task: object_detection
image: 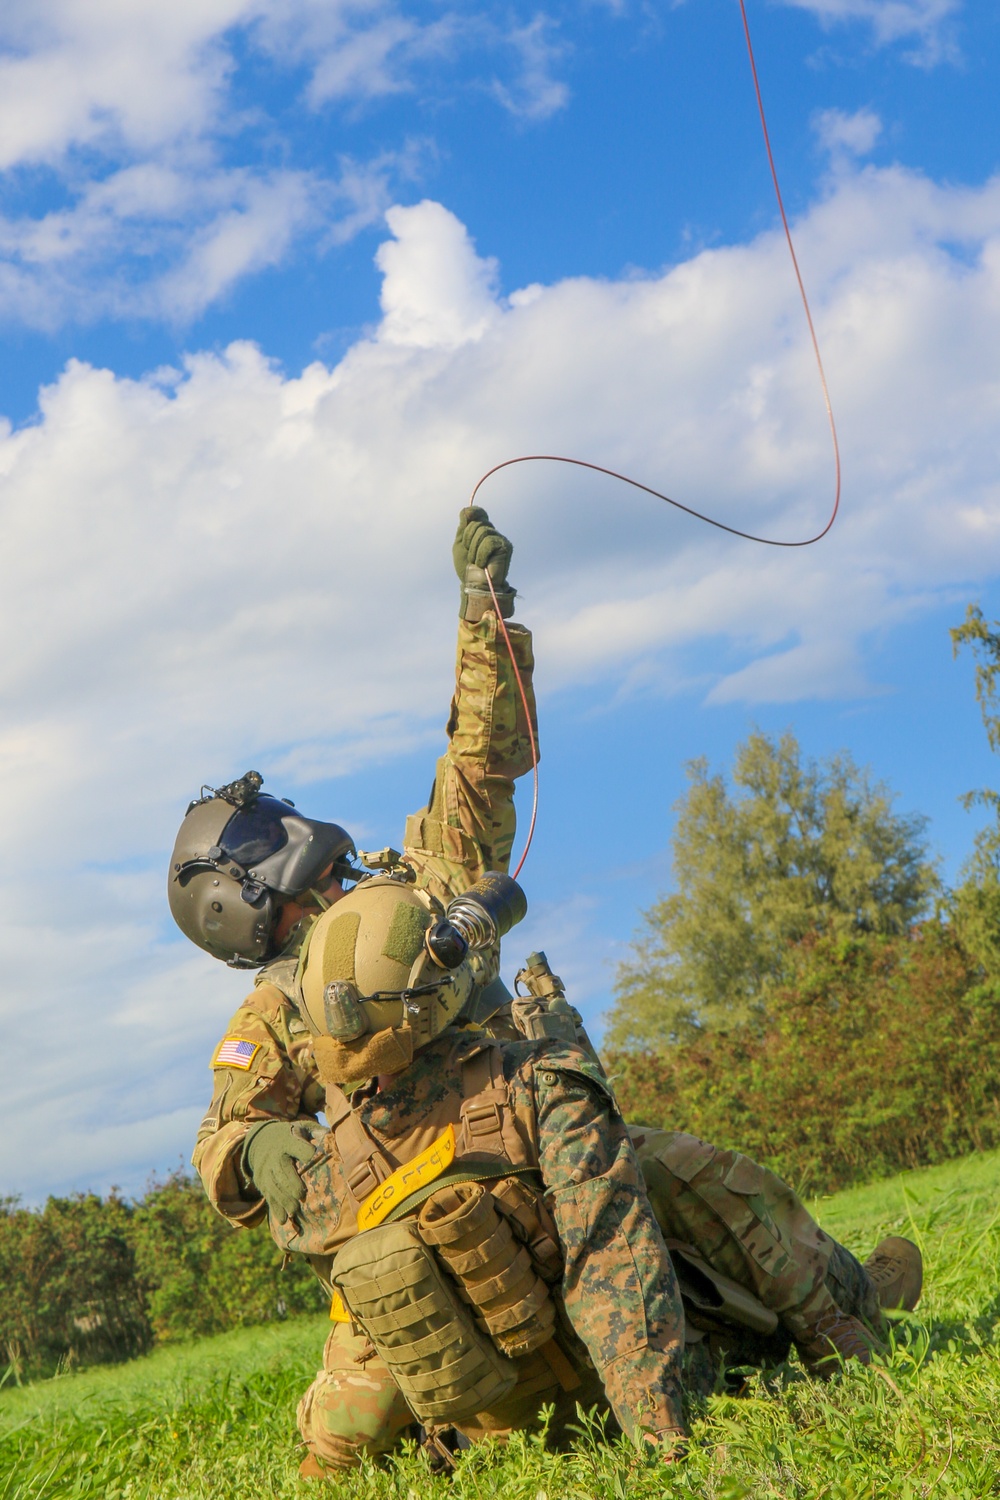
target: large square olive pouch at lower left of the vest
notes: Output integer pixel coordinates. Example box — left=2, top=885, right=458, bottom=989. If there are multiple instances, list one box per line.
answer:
left=330, top=1220, right=517, bottom=1427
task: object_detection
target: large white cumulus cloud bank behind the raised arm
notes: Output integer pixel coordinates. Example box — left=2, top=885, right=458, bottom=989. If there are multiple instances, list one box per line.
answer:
left=0, top=168, right=1000, bottom=1193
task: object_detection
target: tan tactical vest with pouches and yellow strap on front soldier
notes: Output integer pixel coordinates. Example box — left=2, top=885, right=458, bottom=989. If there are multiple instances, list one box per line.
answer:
left=281, top=1032, right=589, bottom=1425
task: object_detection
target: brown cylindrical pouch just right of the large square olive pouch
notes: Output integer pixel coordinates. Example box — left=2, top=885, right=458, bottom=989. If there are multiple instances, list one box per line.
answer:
left=417, top=1182, right=556, bottom=1358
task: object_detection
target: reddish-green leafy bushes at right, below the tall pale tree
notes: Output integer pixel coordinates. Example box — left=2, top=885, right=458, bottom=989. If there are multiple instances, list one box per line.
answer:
left=607, top=923, right=1000, bottom=1193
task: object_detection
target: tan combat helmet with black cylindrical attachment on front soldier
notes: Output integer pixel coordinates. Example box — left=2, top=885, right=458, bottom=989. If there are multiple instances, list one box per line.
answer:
left=301, top=875, right=526, bottom=1085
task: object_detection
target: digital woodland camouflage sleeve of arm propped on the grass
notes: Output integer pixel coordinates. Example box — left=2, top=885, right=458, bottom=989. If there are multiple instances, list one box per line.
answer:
left=532, top=1047, right=684, bottom=1445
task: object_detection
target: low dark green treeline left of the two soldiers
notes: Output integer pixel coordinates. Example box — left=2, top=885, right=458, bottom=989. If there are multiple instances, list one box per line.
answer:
left=0, top=1172, right=324, bottom=1385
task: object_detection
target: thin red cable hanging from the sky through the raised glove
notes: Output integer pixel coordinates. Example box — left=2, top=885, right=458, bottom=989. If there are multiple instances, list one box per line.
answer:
left=469, top=0, right=841, bottom=879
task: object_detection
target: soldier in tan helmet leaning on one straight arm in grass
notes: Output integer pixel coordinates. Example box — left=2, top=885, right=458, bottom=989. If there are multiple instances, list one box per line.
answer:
left=217, top=866, right=919, bottom=1475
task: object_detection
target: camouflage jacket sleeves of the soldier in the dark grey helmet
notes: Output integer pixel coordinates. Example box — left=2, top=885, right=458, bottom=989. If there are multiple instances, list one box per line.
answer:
left=192, top=614, right=537, bottom=1226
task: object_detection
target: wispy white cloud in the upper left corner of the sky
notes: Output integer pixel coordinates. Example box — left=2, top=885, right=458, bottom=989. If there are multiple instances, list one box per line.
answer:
left=0, top=0, right=565, bottom=329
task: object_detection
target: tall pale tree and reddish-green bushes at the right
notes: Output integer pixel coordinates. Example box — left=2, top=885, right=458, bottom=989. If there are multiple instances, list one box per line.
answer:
left=606, top=606, right=1000, bottom=1193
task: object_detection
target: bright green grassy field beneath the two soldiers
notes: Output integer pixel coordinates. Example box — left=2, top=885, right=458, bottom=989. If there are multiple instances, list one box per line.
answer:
left=0, top=1154, right=1000, bottom=1500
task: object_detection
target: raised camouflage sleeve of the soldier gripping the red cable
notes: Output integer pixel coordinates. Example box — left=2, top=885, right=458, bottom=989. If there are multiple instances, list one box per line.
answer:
left=405, top=612, right=538, bottom=902
